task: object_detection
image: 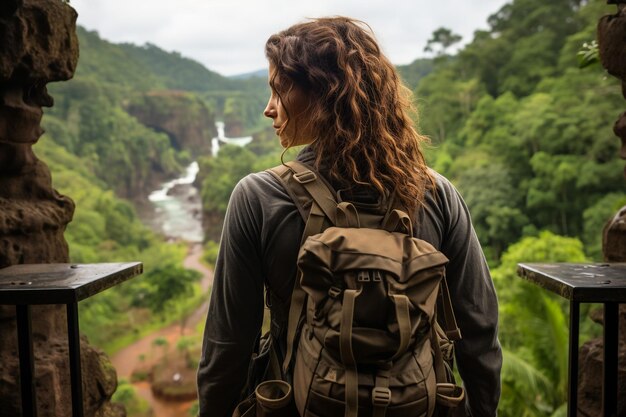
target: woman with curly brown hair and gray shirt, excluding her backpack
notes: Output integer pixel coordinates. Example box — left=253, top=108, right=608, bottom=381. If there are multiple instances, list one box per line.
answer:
left=198, top=17, right=502, bottom=417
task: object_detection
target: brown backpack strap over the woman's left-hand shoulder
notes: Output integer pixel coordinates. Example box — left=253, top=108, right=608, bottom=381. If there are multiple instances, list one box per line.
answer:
left=268, top=161, right=337, bottom=373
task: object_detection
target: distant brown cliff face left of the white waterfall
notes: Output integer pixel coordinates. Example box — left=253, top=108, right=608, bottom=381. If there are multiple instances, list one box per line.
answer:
left=127, top=91, right=217, bottom=159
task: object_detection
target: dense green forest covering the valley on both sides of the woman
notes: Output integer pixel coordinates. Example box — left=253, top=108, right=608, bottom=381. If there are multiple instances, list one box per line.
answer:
left=35, top=0, right=626, bottom=416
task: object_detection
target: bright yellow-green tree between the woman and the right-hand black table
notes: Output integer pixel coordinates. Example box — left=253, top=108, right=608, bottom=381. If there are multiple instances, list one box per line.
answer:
left=492, top=231, right=586, bottom=417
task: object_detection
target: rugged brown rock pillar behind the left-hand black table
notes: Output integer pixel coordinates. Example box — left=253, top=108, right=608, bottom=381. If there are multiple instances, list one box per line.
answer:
left=0, top=0, right=124, bottom=417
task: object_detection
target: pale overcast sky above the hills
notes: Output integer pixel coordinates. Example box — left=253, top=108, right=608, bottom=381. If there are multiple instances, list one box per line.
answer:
left=70, top=0, right=508, bottom=75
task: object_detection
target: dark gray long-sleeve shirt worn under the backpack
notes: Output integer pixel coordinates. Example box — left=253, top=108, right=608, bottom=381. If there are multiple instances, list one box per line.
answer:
left=198, top=152, right=502, bottom=417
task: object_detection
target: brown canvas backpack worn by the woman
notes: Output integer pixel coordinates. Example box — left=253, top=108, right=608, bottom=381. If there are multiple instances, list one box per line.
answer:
left=269, top=162, right=464, bottom=417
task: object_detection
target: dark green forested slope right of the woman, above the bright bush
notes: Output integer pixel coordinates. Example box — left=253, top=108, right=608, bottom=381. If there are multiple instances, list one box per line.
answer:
left=415, top=0, right=625, bottom=264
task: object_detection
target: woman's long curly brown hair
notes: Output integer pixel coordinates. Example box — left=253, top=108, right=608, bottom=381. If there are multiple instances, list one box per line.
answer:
left=265, top=17, right=434, bottom=214
